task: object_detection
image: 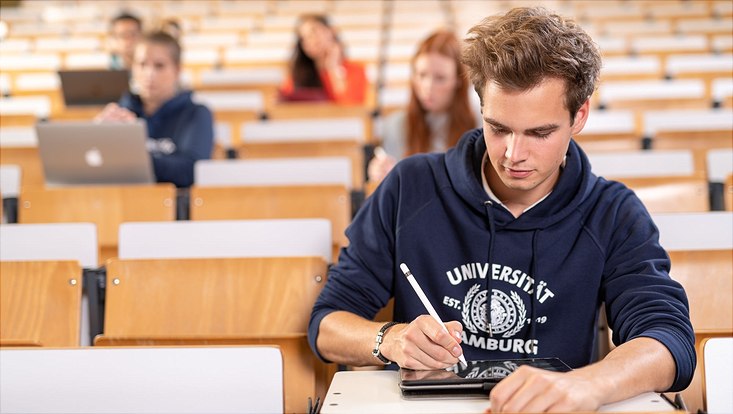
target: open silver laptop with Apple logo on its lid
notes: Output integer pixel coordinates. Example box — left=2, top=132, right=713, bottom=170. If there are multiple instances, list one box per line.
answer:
left=36, top=120, right=155, bottom=186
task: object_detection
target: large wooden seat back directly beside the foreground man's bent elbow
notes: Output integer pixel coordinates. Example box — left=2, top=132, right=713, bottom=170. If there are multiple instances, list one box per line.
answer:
left=95, top=257, right=327, bottom=412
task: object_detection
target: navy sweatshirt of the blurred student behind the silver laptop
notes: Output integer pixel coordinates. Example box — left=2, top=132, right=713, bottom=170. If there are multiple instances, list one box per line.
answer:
left=119, top=91, right=214, bottom=187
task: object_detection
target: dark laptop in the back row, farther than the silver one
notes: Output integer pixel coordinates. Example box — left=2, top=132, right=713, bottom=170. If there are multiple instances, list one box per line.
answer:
left=58, top=69, right=130, bottom=106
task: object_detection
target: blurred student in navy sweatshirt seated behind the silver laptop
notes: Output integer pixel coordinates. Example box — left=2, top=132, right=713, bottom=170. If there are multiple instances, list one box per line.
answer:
left=95, top=32, right=214, bottom=187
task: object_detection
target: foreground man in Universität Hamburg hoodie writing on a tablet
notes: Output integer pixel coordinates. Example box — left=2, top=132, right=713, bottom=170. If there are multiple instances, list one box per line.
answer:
left=308, top=7, right=696, bottom=413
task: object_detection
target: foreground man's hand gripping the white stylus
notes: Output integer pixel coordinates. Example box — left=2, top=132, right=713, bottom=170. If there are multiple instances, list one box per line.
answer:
left=380, top=315, right=463, bottom=369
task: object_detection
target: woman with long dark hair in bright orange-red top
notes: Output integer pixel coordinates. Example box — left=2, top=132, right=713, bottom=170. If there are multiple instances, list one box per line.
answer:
left=280, top=15, right=367, bottom=105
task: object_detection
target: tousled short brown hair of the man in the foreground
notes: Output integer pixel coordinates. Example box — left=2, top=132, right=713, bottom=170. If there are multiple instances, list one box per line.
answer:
left=463, top=7, right=601, bottom=122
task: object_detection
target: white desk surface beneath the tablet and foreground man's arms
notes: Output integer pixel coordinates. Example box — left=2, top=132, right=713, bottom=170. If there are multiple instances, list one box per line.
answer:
left=321, top=370, right=675, bottom=414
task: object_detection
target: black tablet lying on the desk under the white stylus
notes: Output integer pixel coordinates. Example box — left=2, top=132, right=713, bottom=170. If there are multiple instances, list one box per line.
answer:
left=400, top=358, right=571, bottom=397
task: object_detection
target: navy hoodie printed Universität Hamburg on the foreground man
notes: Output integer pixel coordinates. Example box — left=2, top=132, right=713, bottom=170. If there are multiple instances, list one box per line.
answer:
left=308, top=129, right=695, bottom=390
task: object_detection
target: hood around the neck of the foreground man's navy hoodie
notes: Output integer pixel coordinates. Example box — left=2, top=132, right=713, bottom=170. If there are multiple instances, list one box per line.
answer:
left=445, top=128, right=597, bottom=230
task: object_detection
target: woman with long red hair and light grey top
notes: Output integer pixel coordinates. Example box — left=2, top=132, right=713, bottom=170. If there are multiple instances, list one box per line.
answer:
left=368, top=31, right=480, bottom=182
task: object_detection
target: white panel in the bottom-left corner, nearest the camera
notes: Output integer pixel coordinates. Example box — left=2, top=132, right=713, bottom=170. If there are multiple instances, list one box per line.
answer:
left=0, top=346, right=284, bottom=414
